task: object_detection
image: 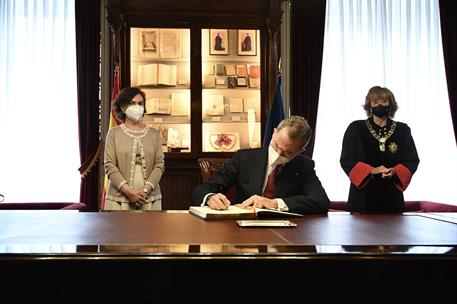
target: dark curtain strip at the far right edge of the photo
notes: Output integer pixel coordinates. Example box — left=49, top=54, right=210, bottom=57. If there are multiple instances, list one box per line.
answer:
left=440, top=0, right=457, bottom=143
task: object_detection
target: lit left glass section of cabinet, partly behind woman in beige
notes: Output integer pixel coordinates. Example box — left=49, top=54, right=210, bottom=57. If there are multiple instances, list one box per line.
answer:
left=130, top=27, right=191, bottom=152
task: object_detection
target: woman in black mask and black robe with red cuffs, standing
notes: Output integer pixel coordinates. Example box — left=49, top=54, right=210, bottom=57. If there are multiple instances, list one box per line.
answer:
left=340, top=86, right=419, bottom=213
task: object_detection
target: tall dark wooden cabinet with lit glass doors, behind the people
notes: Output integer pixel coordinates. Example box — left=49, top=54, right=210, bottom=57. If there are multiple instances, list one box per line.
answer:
left=107, top=0, right=281, bottom=209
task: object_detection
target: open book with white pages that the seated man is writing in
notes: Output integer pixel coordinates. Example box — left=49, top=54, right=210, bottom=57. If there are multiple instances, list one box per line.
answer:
left=189, top=206, right=303, bottom=220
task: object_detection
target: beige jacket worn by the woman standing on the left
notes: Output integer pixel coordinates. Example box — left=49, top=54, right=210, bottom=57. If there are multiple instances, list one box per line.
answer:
left=105, top=126, right=165, bottom=202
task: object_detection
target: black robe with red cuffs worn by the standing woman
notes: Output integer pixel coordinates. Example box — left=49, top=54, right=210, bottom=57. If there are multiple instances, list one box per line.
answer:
left=340, top=118, right=419, bottom=213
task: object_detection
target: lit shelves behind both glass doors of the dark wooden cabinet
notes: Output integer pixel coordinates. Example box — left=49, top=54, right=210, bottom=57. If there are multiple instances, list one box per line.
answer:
left=130, top=27, right=261, bottom=153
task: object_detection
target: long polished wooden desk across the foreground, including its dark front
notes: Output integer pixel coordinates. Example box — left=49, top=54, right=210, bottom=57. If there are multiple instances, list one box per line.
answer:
left=0, top=210, right=457, bottom=303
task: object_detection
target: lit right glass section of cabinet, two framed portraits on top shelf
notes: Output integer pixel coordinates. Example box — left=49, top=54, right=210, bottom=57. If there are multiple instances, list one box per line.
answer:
left=202, top=29, right=261, bottom=152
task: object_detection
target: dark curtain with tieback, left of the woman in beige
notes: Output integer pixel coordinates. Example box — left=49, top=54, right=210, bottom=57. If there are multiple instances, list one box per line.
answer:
left=75, top=0, right=100, bottom=210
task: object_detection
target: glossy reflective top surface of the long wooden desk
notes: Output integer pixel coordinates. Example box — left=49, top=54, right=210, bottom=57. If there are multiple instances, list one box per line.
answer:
left=0, top=210, right=457, bottom=257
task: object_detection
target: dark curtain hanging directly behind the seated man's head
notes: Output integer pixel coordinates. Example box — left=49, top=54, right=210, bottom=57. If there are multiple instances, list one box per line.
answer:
left=290, top=0, right=327, bottom=157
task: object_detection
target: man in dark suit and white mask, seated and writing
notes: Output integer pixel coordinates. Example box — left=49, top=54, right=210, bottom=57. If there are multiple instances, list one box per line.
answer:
left=192, top=116, right=330, bottom=214
